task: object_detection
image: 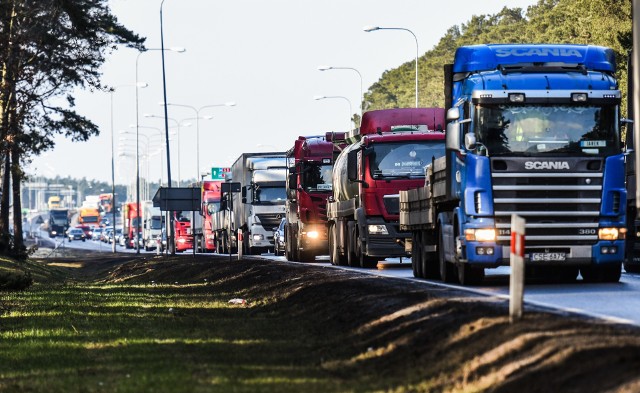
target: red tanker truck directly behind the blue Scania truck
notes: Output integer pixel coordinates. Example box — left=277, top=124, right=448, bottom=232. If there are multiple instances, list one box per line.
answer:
left=327, top=108, right=445, bottom=267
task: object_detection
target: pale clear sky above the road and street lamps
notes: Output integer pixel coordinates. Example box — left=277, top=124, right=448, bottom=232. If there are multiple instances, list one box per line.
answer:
left=26, top=0, right=537, bottom=184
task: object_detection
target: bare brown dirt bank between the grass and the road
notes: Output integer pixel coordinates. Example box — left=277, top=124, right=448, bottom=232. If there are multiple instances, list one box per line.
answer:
left=22, top=254, right=640, bottom=393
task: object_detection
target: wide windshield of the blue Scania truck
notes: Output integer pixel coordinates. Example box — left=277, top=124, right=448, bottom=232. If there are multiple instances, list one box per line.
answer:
left=475, top=105, right=620, bottom=156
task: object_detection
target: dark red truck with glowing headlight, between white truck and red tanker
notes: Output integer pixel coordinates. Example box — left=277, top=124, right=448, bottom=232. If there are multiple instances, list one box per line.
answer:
left=284, top=132, right=346, bottom=262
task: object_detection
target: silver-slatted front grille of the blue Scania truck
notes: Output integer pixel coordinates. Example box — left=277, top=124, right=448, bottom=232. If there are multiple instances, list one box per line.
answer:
left=491, top=158, right=603, bottom=247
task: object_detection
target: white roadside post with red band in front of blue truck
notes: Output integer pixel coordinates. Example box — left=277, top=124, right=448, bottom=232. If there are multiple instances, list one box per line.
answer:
left=509, top=214, right=525, bottom=323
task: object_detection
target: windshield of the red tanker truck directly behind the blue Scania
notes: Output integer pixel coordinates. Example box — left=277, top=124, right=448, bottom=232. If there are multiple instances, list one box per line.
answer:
left=365, top=141, right=445, bottom=179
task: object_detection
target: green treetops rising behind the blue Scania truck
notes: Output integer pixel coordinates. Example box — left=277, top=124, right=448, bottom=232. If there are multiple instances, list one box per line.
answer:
left=364, top=0, right=631, bottom=113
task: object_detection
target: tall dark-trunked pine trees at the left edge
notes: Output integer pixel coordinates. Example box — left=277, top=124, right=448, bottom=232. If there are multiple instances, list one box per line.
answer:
left=0, top=0, right=144, bottom=258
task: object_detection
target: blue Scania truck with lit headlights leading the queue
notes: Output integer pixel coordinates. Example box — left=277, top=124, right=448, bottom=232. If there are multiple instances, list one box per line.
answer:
left=400, top=44, right=627, bottom=285
